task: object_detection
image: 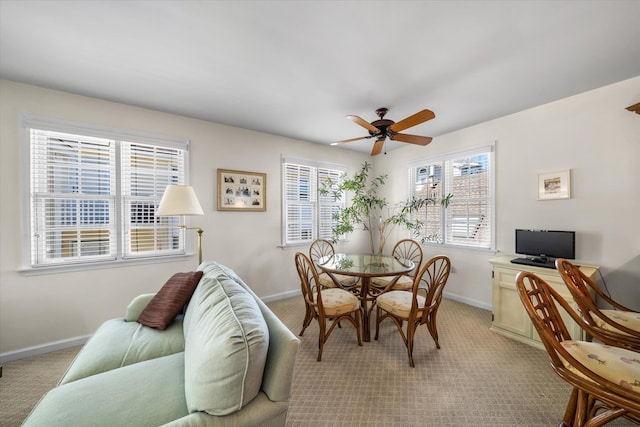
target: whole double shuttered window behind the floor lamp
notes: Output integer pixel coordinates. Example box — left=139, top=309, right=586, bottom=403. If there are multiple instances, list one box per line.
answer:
left=24, top=117, right=188, bottom=267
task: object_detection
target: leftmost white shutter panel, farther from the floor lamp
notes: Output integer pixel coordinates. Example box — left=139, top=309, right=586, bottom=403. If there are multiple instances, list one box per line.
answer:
left=30, top=129, right=117, bottom=267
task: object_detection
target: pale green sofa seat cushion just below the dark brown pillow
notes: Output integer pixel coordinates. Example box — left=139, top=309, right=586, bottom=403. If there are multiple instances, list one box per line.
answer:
left=60, top=316, right=184, bottom=384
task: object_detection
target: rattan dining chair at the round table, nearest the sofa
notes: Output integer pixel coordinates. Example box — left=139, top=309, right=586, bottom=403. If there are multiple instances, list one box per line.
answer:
left=295, top=252, right=362, bottom=362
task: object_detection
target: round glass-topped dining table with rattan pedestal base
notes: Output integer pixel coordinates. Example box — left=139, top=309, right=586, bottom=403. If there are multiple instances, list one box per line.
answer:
left=316, top=254, right=415, bottom=341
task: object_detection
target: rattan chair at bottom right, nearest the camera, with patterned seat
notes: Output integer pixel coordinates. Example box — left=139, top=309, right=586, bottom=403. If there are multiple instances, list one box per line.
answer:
left=516, top=272, right=640, bottom=426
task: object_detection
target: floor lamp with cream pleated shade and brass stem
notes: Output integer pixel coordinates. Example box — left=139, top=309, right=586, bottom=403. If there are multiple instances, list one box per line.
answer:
left=156, top=185, right=204, bottom=265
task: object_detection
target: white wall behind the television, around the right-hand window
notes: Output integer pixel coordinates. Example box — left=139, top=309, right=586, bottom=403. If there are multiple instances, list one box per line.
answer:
left=375, top=77, right=640, bottom=309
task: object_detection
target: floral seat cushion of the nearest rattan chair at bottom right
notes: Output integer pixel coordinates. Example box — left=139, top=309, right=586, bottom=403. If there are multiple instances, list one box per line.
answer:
left=562, top=340, right=640, bottom=399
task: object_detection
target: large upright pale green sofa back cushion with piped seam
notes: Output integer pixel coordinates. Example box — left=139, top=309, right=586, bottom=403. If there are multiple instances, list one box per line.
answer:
left=184, top=268, right=269, bottom=415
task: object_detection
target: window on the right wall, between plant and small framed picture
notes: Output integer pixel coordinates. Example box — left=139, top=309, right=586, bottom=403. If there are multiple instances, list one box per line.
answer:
left=409, top=145, right=494, bottom=249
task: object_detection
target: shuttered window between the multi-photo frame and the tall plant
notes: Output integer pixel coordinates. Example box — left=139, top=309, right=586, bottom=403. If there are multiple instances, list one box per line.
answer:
left=282, top=159, right=344, bottom=246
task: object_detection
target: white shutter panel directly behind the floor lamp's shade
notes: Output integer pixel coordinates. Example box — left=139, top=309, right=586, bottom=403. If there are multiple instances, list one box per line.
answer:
left=121, top=142, right=185, bottom=258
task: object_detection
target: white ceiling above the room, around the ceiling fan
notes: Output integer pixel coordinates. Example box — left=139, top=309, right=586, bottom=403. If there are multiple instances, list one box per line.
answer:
left=0, top=0, right=640, bottom=152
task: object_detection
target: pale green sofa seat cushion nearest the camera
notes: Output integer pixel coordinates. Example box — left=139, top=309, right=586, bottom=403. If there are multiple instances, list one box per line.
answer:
left=23, top=352, right=188, bottom=427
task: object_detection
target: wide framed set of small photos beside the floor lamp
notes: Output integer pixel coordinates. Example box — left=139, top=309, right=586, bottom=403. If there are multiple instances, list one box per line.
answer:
left=218, top=169, right=267, bottom=212
